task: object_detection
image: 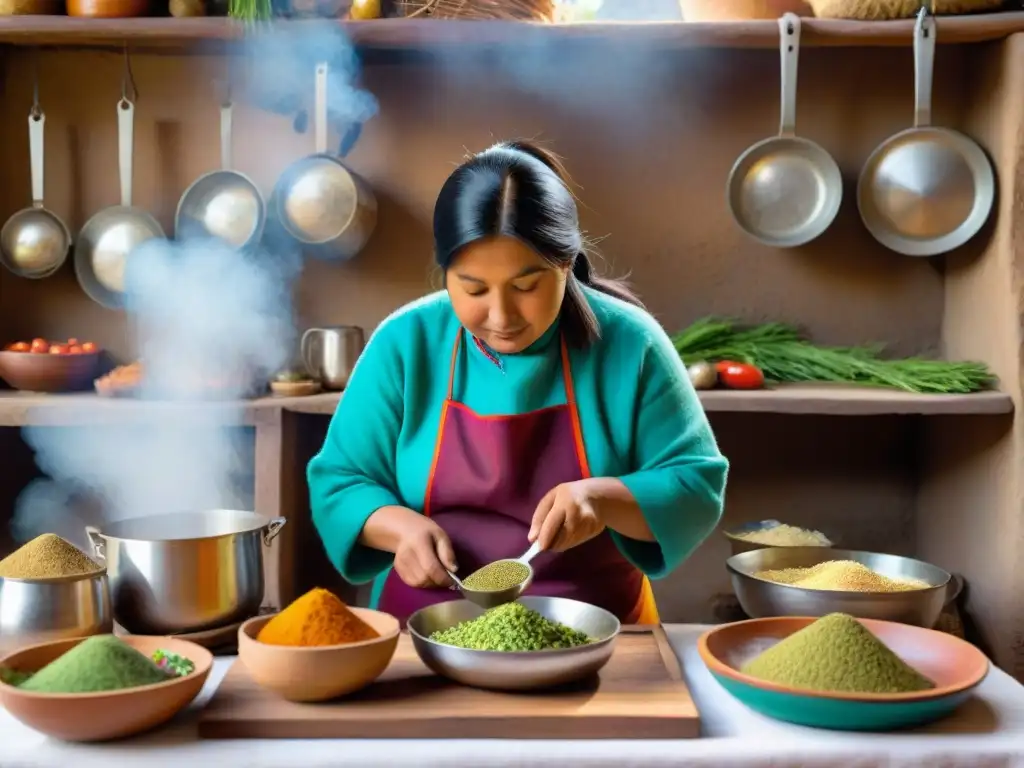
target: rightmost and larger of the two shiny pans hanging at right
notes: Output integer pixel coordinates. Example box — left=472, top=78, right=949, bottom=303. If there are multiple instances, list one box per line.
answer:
left=857, top=8, right=995, bottom=256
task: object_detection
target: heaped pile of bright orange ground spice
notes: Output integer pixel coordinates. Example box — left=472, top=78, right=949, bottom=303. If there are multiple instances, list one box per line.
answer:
left=256, top=588, right=380, bottom=647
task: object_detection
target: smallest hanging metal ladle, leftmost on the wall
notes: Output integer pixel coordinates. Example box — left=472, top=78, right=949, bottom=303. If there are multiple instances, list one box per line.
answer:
left=0, top=60, right=71, bottom=280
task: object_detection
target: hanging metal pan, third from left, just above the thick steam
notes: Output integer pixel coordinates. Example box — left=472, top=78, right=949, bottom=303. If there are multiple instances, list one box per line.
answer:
left=174, top=96, right=266, bottom=248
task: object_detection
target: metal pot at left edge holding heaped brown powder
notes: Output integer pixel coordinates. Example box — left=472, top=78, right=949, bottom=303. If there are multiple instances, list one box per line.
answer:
left=0, top=570, right=114, bottom=651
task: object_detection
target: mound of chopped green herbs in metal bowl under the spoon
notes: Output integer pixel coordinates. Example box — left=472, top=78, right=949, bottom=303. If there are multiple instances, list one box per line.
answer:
left=430, top=603, right=590, bottom=651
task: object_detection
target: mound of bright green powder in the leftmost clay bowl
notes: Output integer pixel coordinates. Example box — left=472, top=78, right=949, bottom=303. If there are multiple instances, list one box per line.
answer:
left=18, top=635, right=170, bottom=693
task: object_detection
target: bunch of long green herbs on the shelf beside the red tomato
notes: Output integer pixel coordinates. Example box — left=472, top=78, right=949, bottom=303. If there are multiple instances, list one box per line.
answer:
left=672, top=317, right=995, bottom=394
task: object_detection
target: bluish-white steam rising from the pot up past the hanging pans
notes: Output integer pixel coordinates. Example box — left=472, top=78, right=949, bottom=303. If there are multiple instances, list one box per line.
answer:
left=11, top=25, right=377, bottom=551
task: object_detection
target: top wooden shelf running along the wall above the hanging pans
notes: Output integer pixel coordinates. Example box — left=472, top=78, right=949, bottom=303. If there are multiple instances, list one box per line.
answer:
left=0, top=11, right=1024, bottom=50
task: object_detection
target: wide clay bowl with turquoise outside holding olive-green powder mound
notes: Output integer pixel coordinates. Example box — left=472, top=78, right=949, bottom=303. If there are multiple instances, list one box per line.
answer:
left=697, top=616, right=989, bottom=731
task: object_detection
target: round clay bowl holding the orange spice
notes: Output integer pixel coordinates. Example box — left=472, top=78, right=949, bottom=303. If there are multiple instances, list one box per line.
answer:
left=239, top=608, right=399, bottom=701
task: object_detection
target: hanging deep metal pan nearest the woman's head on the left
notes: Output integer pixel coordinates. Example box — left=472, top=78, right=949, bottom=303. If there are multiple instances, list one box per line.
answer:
left=270, top=62, right=377, bottom=260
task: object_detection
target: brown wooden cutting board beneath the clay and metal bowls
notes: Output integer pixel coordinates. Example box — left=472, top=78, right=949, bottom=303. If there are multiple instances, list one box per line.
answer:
left=199, top=627, right=700, bottom=739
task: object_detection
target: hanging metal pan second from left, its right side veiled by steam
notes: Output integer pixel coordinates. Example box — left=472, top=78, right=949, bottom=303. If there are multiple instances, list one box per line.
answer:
left=75, top=59, right=166, bottom=309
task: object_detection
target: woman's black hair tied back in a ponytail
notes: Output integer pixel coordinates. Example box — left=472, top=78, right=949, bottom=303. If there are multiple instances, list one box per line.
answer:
left=434, top=141, right=643, bottom=347
